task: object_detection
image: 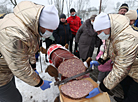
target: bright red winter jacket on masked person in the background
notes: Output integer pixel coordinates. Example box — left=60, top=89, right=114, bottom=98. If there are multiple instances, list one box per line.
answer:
left=67, top=16, right=81, bottom=35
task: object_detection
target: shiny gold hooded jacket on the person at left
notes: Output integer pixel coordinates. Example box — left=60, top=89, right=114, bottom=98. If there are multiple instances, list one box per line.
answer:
left=0, top=1, right=44, bottom=86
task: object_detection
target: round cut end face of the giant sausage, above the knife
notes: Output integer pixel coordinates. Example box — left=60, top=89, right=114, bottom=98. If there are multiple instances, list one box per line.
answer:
left=58, top=59, right=86, bottom=77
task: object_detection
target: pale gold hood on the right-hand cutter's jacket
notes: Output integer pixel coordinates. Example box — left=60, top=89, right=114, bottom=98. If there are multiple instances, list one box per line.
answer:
left=109, top=14, right=129, bottom=39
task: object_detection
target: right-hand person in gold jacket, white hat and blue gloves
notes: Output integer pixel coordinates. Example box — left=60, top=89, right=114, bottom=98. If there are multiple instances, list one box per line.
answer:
left=86, top=13, right=138, bottom=102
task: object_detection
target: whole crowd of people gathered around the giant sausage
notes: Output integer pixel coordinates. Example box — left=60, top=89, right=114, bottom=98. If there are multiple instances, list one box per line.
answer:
left=0, top=1, right=138, bottom=102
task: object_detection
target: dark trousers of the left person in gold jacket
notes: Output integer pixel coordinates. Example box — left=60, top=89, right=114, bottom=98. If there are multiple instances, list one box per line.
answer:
left=0, top=77, right=22, bottom=102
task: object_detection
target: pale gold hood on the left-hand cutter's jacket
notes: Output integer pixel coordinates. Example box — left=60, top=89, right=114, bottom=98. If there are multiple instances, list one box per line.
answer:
left=14, top=1, right=44, bottom=34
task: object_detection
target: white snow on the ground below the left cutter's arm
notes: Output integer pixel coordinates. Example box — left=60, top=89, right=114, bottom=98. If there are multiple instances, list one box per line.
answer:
left=15, top=41, right=59, bottom=102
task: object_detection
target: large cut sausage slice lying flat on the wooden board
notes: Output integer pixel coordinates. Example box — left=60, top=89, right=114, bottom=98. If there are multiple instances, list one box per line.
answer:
left=60, top=80, right=94, bottom=99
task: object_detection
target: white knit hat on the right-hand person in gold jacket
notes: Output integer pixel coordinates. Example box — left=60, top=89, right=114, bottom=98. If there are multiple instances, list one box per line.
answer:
left=93, top=12, right=111, bottom=31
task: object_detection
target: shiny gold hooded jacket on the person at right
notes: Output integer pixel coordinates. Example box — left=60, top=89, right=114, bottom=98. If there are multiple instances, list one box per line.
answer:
left=98, top=14, right=138, bottom=89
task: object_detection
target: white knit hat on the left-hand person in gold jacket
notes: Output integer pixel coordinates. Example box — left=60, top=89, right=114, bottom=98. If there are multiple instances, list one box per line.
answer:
left=39, top=5, right=59, bottom=30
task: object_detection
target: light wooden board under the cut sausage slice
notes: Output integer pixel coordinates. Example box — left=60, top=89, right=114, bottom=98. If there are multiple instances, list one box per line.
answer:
left=59, top=78, right=111, bottom=102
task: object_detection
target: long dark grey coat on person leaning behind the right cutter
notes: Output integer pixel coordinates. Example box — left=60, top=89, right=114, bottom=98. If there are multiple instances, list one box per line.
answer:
left=75, top=19, right=100, bottom=59
